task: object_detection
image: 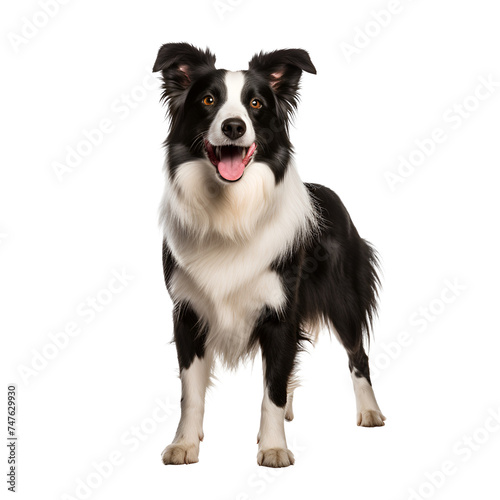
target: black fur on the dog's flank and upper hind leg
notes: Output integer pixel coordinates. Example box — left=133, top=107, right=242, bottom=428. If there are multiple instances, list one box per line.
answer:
left=298, top=184, right=380, bottom=382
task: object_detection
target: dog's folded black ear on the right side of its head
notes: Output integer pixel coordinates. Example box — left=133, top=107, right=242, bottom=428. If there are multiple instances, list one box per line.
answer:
left=248, top=49, right=316, bottom=117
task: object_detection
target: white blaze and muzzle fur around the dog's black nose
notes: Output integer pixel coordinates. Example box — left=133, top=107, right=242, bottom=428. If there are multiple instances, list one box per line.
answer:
left=207, top=71, right=255, bottom=147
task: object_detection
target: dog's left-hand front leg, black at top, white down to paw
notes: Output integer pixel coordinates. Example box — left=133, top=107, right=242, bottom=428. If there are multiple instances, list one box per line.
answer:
left=162, top=306, right=212, bottom=465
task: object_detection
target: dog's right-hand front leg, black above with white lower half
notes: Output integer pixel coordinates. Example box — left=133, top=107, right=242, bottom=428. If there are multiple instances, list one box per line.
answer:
left=256, top=312, right=297, bottom=467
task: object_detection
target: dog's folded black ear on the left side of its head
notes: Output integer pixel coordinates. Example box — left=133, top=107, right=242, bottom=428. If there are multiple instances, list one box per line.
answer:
left=153, top=43, right=215, bottom=108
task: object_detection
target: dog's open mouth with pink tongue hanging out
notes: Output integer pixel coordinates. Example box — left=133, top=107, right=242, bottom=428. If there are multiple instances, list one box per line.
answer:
left=205, top=141, right=257, bottom=182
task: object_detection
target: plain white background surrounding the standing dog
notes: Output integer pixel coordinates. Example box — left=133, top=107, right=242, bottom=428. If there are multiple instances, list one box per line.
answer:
left=0, top=0, right=500, bottom=500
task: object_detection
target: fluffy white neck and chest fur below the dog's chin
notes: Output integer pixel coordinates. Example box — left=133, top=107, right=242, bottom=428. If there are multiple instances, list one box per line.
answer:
left=161, top=161, right=314, bottom=365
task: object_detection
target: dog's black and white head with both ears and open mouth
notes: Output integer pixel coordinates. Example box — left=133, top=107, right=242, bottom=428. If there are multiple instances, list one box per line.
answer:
left=153, top=43, right=316, bottom=182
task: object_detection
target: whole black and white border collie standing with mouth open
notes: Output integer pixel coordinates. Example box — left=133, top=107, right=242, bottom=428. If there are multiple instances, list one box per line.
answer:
left=153, top=43, right=385, bottom=467
